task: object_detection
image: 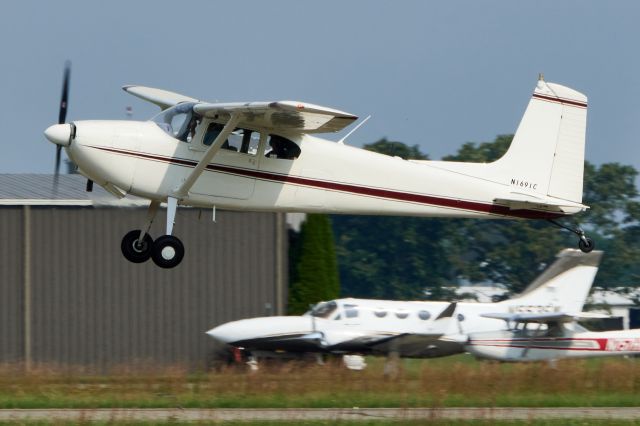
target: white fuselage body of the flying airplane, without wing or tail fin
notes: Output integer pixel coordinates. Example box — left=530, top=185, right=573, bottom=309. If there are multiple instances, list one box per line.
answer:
left=66, top=120, right=579, bottom=218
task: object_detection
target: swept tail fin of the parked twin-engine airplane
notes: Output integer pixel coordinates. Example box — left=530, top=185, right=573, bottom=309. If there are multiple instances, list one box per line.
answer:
left=500, top=249, right=602, bottom=312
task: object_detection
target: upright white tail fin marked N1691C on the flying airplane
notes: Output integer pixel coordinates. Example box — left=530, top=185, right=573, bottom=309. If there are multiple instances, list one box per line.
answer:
left=487, top=79, right=587, bottom=204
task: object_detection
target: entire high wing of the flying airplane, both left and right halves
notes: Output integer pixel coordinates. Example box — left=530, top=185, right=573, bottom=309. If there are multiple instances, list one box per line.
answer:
left=123, top=86, right=358, bottom=133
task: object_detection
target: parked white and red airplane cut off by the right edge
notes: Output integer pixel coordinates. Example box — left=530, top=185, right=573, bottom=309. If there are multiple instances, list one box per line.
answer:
left=465, top=312, right=640, bottom=362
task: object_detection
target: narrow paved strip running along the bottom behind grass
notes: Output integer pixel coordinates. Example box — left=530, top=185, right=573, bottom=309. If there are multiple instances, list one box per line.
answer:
left=0, top=407, right=640, bottom=422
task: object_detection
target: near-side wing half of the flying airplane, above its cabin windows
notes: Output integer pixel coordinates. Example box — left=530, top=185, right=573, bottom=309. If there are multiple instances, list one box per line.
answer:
left=193, top=101, right=358, bottom=133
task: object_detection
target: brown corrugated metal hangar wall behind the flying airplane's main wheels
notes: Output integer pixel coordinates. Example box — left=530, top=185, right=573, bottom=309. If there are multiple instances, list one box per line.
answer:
left=0, top=207, right=286, bottom=368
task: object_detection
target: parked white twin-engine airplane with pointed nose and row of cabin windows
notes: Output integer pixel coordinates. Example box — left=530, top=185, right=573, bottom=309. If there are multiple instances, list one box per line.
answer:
left=207, top=249, right=602, bottom=366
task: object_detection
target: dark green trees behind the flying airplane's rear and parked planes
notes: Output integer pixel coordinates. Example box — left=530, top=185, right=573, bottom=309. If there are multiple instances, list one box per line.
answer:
left=290, top=135, right=640, bottom=312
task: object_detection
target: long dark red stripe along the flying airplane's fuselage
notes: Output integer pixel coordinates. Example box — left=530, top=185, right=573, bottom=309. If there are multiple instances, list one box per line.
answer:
left=88, top=145, right=564, bottom=219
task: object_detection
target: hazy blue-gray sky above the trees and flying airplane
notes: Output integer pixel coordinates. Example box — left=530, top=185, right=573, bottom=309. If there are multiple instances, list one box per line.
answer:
left=0, top=0, right=640, bottom=173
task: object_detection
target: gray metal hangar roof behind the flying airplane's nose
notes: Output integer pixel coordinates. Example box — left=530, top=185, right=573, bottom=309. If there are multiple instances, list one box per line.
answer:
left=0, top=173, right=146, bottom=206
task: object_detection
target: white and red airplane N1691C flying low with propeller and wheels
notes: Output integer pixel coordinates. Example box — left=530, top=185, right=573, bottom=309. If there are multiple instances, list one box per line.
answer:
left=45, top=66, right=593, bottom=268
